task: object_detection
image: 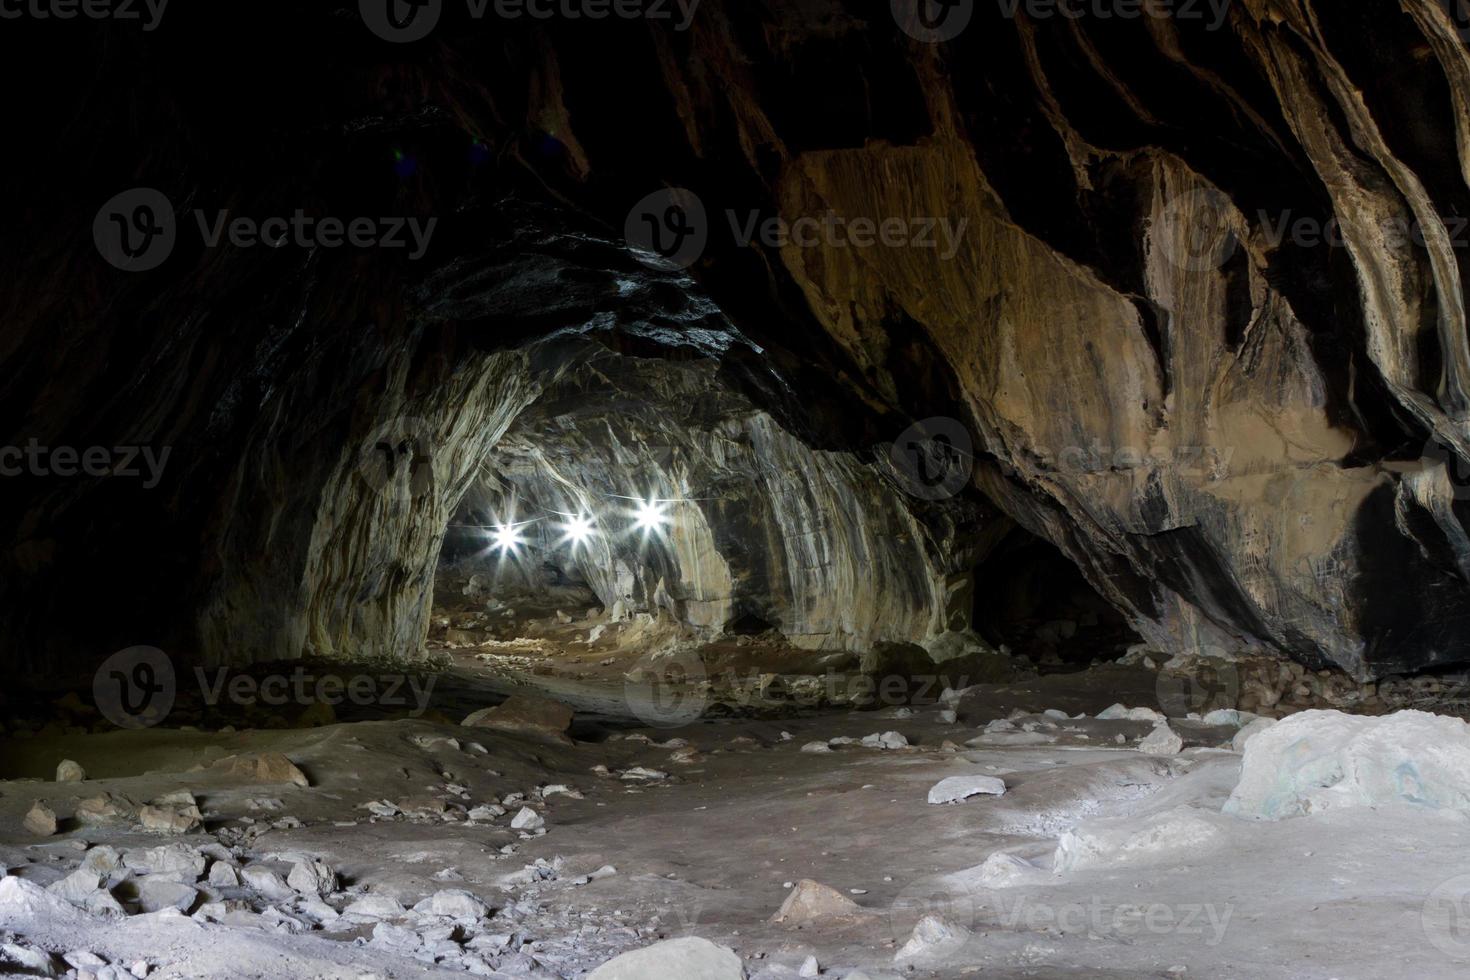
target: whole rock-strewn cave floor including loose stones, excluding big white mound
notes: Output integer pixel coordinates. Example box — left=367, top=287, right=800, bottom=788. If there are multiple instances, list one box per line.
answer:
left=0, top=605, right=1470, bottom=980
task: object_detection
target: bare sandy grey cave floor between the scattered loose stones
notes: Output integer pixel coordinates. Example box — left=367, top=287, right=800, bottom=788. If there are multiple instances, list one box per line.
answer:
left=0, top=654, right=1470, bottom=979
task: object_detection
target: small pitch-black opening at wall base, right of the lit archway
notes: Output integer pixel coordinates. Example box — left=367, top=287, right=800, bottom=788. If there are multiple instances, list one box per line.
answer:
left=972, top=526, right=1142, bottom=670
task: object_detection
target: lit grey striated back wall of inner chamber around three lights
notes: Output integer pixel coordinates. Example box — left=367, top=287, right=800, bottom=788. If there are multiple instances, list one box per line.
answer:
left=466, top=340, right=979, bottom=651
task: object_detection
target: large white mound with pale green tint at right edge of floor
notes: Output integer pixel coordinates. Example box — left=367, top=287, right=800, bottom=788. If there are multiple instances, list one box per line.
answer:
left=1225, top=711, right=1470, bottom=820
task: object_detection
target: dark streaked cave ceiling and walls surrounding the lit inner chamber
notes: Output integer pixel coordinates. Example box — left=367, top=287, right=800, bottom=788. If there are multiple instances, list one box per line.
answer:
left=0, top=0, right=1470, bottom=677
